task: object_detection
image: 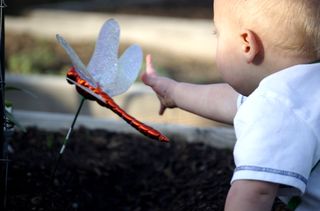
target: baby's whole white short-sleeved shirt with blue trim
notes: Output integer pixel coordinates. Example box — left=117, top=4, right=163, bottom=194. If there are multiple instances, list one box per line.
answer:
left=231, top=63, right=320, bottom=211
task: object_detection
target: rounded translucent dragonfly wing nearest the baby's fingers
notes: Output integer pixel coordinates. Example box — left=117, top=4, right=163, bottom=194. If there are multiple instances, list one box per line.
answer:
left=101, top=45, right=143, bottom=96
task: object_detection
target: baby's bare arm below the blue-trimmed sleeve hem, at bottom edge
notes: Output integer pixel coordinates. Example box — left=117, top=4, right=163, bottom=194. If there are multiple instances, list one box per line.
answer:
left=225, top=180, right=278, bottom=211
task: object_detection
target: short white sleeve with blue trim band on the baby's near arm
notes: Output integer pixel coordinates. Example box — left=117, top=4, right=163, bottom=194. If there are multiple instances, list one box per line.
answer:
left=231, top=92, right=316, bottom=196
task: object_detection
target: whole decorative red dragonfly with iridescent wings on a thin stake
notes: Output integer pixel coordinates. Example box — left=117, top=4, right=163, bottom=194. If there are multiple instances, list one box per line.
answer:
left=56, top=19, right=169, bottom=144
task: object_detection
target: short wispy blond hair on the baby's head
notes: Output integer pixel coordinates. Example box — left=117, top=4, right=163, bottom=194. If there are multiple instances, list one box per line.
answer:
left=232, top=0, right=320, bottom=59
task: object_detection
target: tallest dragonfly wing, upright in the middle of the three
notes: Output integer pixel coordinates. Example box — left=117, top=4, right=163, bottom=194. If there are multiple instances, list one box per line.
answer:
left=88, top=19, right=120, bottom=85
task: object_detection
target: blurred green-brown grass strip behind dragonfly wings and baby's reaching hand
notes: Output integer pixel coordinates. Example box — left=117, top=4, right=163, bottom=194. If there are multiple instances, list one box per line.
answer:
left=5, top=33, right=219, bottom=83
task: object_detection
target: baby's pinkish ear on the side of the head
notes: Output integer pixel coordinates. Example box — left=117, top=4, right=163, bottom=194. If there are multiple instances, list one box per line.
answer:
left=241, top=29, right=262, bottom=64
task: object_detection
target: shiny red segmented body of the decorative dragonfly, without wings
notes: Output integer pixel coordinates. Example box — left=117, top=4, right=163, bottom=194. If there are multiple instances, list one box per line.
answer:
left=67, top=67, right=169, bottom=142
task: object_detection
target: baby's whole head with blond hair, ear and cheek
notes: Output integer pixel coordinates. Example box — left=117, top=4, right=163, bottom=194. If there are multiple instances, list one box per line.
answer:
left=214, top=0, right=320, bottom=95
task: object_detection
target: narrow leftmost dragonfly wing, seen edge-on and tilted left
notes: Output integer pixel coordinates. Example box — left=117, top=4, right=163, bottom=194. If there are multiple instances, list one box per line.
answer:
left=56, top=34, right=97, bottom=87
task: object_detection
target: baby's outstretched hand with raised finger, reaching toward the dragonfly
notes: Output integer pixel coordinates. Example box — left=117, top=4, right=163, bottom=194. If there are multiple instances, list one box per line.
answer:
left=141, top=54, right=177, bottom=115
